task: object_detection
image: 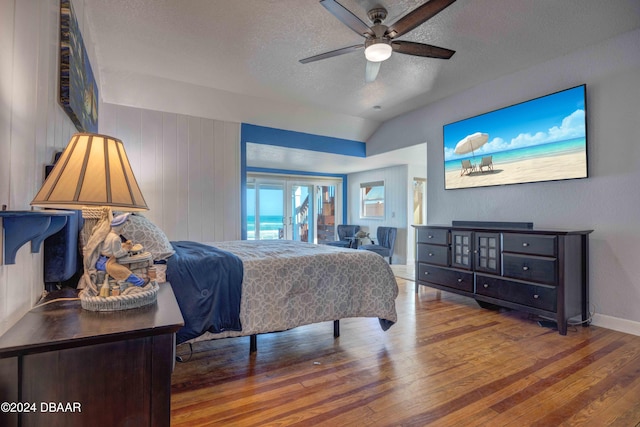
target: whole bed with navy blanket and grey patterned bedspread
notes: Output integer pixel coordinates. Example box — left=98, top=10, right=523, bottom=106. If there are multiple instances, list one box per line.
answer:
left=166, top=240, right=398, bottom=351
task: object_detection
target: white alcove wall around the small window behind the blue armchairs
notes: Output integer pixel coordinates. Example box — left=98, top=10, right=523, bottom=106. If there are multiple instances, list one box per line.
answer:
left=347, top=165, right=413, bottom=264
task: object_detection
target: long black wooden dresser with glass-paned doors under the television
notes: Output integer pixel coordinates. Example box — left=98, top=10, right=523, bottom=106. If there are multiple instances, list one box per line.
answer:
left=414, top=222, right=592, bottom=335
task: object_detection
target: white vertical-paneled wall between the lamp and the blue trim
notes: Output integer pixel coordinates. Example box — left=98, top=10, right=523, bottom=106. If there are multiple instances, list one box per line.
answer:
left=99, top=103, right=241, bottom=242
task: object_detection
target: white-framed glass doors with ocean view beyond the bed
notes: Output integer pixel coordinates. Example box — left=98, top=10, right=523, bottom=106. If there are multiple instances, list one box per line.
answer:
left=247, top=175, right=341, bottom=243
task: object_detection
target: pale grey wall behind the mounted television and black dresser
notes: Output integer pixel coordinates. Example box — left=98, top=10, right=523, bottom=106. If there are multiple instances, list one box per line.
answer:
left=367, top=30, right=640, bottom=334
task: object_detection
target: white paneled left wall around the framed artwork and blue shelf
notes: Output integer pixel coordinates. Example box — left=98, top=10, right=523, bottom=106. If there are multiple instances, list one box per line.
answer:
left=0, top=0, right=99, bottom=334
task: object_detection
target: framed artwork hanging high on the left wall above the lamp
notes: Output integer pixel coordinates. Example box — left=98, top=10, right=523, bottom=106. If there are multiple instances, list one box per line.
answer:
left=60, top=0, right=99, bottom=133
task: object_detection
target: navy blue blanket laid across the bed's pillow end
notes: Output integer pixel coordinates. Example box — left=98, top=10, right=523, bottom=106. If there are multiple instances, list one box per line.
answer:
left=167, top=241, right=243, bottom=344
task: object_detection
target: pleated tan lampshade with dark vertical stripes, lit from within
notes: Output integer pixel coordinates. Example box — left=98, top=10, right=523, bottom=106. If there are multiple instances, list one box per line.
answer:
left=31, top=133, right=149, bottom=211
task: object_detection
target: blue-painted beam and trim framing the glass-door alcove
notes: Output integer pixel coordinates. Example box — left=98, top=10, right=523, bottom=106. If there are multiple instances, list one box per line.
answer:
left=240, top=123, right=366, bottom=239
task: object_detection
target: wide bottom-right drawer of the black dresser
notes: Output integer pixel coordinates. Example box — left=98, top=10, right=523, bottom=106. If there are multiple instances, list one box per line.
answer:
left=476, top=274, right=558, bottom=312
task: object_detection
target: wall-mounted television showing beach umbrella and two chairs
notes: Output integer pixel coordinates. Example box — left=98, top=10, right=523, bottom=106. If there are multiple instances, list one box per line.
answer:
left=443, top=85, right=587, bottom=190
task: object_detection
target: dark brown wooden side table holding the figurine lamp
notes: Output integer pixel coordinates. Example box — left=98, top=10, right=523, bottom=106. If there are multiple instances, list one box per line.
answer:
left=0, top=284, right=184, bottom=427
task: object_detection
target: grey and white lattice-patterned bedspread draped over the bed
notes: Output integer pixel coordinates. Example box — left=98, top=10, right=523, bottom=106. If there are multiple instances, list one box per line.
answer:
left=182, top=240, right=398, bottom=342
